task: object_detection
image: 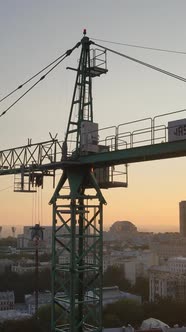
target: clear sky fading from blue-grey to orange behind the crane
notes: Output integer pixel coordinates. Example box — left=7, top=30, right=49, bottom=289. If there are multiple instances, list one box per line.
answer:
left=0, top=0, right=186, bottom=230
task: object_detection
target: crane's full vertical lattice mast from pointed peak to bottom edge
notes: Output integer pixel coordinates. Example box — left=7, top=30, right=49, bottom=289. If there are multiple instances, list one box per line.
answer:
left=51, top=30, right=105, bottom=332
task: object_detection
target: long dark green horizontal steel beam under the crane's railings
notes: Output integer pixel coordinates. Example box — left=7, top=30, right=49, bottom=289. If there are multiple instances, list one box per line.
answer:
left=0, top=140, right=186, bottom=176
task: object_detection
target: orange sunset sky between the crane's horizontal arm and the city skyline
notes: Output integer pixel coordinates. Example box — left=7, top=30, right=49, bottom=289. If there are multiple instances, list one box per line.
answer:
left=0, top=158, right=186, bottom=232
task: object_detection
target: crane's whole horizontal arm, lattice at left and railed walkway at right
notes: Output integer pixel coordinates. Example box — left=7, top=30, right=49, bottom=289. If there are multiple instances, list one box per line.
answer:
left=0, top=109, right=186, bottom=175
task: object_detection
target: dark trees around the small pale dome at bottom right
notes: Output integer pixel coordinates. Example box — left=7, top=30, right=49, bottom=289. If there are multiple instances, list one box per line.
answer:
left=103, top=298, right=186, bottom=329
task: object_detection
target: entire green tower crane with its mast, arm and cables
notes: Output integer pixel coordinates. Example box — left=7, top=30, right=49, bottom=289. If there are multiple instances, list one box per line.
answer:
left=0, top=30, right=186, bottom=332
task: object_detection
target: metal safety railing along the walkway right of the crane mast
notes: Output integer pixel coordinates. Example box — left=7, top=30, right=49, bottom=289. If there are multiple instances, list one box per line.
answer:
left=86, top=109, right=186, bottom=152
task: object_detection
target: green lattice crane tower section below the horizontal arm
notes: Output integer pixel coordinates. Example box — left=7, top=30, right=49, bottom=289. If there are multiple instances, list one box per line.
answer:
left=52, top=167, right=105, bottom=332
